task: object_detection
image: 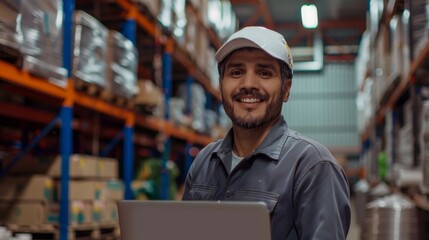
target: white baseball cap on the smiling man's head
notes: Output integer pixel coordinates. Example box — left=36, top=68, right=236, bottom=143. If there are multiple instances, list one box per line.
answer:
left=216, top=26, right=293, bottom=71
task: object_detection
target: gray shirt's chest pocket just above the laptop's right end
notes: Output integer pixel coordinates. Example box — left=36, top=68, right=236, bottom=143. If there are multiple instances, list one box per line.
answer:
left=233, top=190, right=279, bottom=214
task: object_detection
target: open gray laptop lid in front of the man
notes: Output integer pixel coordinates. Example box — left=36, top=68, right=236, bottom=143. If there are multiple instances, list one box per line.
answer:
left=118, top=200, right=271, bottom=240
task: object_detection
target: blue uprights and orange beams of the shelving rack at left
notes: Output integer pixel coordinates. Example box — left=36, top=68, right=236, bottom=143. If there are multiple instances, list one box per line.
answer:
left=0, top=0, right=226, bottom=240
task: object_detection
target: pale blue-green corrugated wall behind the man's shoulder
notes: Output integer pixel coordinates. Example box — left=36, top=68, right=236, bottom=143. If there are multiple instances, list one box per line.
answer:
left=282, top=62, right=360, bottom=152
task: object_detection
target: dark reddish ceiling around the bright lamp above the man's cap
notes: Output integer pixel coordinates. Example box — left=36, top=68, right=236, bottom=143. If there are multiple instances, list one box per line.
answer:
left=231, top=0, right=369, bottom=57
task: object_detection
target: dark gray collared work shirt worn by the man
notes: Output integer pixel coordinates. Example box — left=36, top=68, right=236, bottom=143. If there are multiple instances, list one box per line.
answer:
left=183, top=117, right=350, bottom=240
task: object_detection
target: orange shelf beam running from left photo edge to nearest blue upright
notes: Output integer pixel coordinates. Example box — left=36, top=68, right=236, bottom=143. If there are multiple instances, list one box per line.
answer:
left=0, top=60, right=66, bottom=99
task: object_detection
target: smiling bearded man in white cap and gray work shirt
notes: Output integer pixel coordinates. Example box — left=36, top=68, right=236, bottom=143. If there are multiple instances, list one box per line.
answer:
left=183, top=27, right=350, bottom=240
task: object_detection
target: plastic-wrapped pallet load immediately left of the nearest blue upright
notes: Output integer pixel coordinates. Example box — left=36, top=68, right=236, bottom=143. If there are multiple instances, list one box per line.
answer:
left=19, top=0, right=67, bottom=86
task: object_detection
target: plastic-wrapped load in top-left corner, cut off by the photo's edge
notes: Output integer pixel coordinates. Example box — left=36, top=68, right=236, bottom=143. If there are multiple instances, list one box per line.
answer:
left=0, top=0, right=22, bottom=49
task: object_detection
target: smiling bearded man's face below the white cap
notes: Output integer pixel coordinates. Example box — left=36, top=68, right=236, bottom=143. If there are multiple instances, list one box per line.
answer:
left=220, top=49, right=290, bottom=129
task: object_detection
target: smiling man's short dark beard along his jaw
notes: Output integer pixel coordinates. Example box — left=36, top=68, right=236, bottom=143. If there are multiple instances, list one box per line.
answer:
left=223, top=90, right=283, bottom=129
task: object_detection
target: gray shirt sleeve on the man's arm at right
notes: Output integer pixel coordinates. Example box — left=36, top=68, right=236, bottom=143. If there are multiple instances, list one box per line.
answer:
left=294, top=161, right=351, bottom=240
